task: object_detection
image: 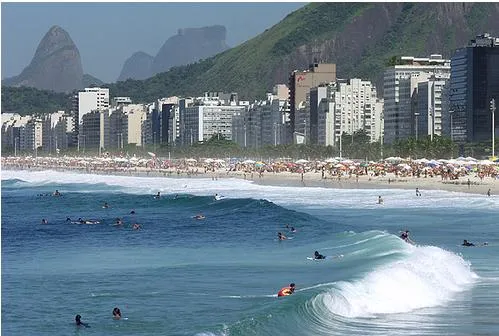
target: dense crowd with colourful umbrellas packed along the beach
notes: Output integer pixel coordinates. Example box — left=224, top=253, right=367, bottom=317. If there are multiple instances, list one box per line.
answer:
left=2, top=156, right=499, bottom=183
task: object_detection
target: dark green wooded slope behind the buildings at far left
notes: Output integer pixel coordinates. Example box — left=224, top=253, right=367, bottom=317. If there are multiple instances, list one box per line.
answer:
left=2, top=86, right=71, bottom=116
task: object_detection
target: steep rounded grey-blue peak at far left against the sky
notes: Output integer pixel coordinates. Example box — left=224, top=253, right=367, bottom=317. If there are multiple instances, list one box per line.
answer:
left=2, top=26, right=83, bottom=92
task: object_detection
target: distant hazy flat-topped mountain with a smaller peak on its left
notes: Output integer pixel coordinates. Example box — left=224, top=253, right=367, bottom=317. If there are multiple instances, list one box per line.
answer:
left=118, top=25, right=228, bottom=81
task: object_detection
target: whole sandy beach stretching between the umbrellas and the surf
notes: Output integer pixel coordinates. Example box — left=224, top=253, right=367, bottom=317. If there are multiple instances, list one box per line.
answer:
left=2, top=158, right=499, bottom=195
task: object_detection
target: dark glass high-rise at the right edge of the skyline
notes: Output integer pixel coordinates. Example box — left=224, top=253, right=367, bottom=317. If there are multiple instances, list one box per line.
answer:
left=449, top=34, right=499, bottom=143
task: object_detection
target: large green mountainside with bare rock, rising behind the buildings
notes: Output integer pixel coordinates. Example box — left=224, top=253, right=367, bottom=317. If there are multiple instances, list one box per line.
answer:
left=110, top=2, right=499, bottom=102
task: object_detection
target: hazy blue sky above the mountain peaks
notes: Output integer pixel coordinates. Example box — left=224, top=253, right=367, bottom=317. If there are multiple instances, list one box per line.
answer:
left=1, top=2, right=305, bottom=83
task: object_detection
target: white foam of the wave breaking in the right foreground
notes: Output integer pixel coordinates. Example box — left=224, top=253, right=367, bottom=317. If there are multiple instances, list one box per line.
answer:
left=312, top=246, right=477, bottom=318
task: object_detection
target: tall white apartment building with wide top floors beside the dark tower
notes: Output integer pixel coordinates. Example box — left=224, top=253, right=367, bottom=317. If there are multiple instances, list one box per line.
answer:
left=384, top=54, right=450, bottom=143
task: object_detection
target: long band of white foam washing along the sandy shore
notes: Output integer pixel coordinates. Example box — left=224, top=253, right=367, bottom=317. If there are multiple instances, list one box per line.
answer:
left=2, top=170, right=499, bottom=209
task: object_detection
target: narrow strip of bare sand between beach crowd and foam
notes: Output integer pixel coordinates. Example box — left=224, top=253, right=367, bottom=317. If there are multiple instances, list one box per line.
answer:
left=2, top=165, right=499, bottom=196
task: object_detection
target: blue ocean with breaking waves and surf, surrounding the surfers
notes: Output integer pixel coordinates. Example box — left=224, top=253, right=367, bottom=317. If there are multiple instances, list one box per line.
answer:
left=1, top=170, right=499, bottom=336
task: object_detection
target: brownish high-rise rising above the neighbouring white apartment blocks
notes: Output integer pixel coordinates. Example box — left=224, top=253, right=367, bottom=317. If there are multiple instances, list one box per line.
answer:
left=289, top=63, right=336, bottom=137
